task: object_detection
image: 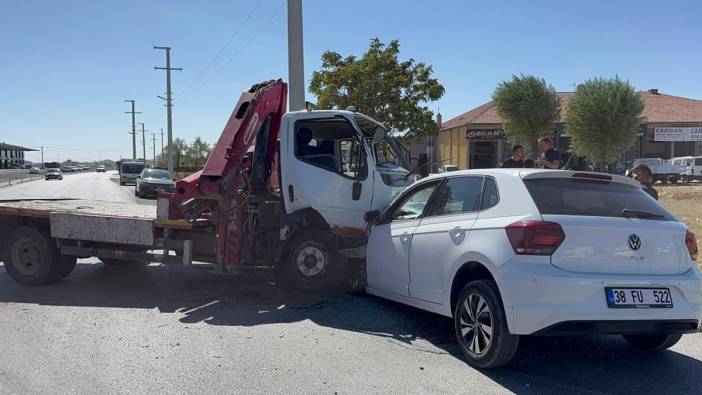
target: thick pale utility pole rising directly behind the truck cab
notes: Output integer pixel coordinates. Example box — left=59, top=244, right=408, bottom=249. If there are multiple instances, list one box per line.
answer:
left=288, top=0, right=305, bottom=111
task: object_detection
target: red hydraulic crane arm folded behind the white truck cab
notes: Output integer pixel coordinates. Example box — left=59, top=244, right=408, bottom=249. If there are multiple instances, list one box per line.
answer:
left=172, top=80, right=287, bottom=202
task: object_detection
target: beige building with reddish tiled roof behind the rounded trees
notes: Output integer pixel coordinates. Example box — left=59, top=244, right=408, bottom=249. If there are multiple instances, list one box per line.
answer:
left=434, top=89, right=702, bottom=169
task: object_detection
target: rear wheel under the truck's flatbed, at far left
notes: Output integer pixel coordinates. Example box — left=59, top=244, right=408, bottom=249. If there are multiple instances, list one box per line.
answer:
left=3, top=226, right=76, bottom=285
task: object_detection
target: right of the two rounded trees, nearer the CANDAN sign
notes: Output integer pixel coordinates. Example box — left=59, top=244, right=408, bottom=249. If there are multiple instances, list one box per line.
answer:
left=565, top=76, right=644, bottom=169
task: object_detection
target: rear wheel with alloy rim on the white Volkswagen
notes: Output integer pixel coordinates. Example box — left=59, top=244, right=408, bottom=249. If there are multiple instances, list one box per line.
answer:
left=453, top=280, right=519, bottom=368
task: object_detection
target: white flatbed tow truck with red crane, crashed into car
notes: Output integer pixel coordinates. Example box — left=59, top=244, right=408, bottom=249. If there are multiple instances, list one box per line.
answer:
left=0, top=80, right=413, bottom=291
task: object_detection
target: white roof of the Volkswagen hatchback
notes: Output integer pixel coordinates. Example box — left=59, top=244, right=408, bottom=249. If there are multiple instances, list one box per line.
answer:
left=421, top=168, right=641, bottom=187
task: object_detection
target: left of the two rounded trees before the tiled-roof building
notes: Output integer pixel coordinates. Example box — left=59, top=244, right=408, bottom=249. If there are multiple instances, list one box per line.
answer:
left=492, top=74, right=561, bottom=154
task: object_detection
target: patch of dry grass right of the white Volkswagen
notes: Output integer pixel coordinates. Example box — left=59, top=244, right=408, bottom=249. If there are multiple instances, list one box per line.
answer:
left=655, top=183, right=702, bottom=268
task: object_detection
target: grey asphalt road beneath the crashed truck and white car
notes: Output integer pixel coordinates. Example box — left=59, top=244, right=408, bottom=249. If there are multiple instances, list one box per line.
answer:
left=0, top=174, right=702, bottom=394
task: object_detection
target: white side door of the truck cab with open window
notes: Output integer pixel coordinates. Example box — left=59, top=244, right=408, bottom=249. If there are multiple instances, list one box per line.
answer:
left=281, top=113, right=373, bottom=229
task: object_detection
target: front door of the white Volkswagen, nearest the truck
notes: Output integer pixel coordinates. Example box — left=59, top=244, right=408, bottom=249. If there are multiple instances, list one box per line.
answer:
left=366, top=181, right=440, bottom=296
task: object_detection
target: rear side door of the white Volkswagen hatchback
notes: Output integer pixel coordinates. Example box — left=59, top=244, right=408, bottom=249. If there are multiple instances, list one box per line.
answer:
left=409, top=176, right=483, bottom=304
